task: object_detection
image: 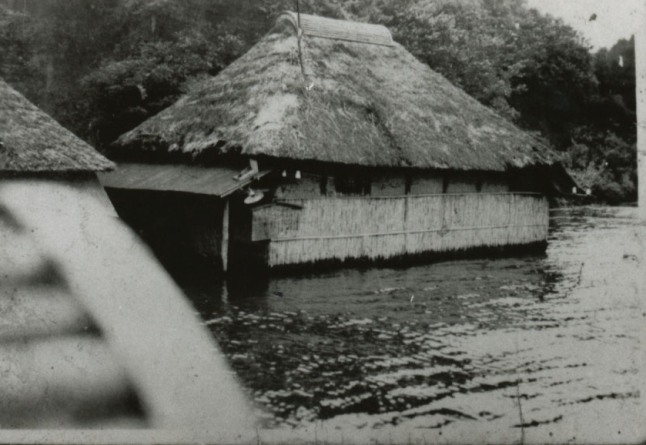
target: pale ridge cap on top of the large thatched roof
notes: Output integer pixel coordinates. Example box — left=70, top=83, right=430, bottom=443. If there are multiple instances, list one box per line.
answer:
left=279, top=11, right=393, bottom=46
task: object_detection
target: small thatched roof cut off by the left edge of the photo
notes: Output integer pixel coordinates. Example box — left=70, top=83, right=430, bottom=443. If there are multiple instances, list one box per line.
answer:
left=0, top=79, right=114, bottom=172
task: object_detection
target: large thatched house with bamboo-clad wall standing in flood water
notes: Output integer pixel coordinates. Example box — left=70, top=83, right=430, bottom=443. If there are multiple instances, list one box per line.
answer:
left=104, top=12, right=576, bottom=266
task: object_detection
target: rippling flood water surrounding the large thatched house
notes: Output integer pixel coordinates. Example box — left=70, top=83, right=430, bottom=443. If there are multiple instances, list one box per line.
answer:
left=173, top=207, right=646, bottom=443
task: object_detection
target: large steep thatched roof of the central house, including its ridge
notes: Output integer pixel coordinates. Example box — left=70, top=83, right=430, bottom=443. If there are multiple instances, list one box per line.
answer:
left=113, top=13, right=554, bottom=171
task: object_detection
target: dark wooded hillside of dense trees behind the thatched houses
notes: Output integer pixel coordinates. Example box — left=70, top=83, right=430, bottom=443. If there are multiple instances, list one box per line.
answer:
left=0, top=0, right=637, bottom=204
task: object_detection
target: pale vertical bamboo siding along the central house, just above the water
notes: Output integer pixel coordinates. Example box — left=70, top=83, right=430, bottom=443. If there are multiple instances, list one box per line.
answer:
left=253, top=193, right=548, bottom=266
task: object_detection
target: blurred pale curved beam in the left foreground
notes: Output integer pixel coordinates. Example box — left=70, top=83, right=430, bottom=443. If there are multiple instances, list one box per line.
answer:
left=0, top=179, right=251, bottom=432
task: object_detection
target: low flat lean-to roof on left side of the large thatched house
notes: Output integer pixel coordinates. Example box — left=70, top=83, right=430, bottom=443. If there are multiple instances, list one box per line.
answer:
left=99, top=163, right=268, bottom=197
